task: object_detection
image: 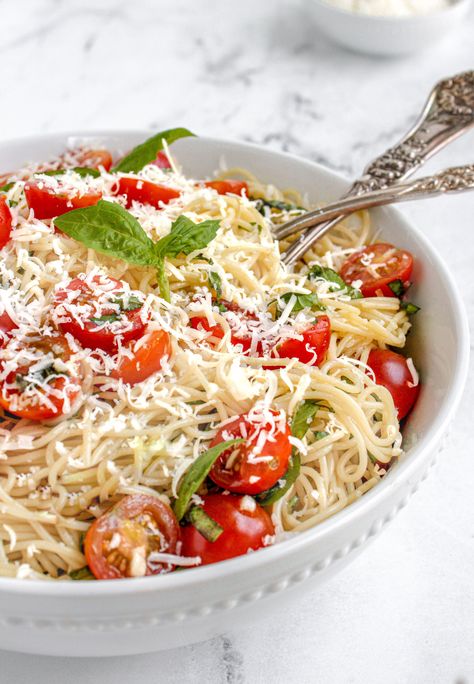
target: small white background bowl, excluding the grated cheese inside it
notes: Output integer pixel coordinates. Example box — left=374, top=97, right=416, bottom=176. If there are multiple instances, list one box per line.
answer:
left=312, top=0, right=472, bottom=56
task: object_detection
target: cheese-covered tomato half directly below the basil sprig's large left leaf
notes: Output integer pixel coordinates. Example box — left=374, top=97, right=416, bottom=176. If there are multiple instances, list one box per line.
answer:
left=53, top=275, right=146, bottom=351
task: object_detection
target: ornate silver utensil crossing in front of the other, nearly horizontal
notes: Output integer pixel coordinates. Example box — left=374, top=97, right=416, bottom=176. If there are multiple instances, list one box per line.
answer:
left=274, top=164, right=474, bottom=240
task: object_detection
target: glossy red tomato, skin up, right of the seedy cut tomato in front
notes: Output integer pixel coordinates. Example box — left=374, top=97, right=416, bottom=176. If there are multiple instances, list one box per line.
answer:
left=182, top=494, right=275, bottom=565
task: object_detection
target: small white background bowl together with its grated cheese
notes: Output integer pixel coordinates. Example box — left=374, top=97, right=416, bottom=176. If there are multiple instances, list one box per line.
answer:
left=311, top=0, right=472, bottom=56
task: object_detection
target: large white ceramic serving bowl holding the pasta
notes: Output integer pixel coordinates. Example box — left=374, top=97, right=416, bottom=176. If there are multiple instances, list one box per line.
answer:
left=0, top=132, right=469, bottom=656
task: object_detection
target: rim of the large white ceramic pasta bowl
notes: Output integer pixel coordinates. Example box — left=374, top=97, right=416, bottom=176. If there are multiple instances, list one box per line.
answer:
left=0, top=130, right=469, bottom=597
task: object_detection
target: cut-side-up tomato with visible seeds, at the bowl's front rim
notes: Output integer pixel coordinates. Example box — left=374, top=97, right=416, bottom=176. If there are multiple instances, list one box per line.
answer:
left=84, top=494, right=180, bottom=579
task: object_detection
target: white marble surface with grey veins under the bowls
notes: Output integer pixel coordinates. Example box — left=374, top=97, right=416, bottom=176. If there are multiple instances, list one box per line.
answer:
left=0, top=0, right=474, bottom=684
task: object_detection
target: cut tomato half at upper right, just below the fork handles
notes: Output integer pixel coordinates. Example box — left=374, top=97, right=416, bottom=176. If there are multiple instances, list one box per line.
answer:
left=340, top=242, right=413, bottom=297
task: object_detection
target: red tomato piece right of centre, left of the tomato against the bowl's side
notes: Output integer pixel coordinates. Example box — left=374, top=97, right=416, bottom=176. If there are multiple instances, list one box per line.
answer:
left=267, top=316, right=331, bottom=369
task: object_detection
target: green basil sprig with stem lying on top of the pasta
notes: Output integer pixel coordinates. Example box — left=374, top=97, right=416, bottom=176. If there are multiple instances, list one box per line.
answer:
left=54, top=200, right=219, bottom=301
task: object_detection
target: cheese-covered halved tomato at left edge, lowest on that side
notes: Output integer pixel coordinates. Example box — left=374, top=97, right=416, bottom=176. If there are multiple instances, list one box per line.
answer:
left=0, top=336, right=82, bottom=420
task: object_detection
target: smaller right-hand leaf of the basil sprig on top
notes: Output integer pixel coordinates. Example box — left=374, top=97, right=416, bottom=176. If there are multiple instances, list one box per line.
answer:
left=155, top=216, right=220, bottom=258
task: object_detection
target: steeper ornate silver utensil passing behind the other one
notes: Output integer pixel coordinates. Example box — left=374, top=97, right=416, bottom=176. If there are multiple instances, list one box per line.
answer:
left=282, top=71, right=474, bottom=264
